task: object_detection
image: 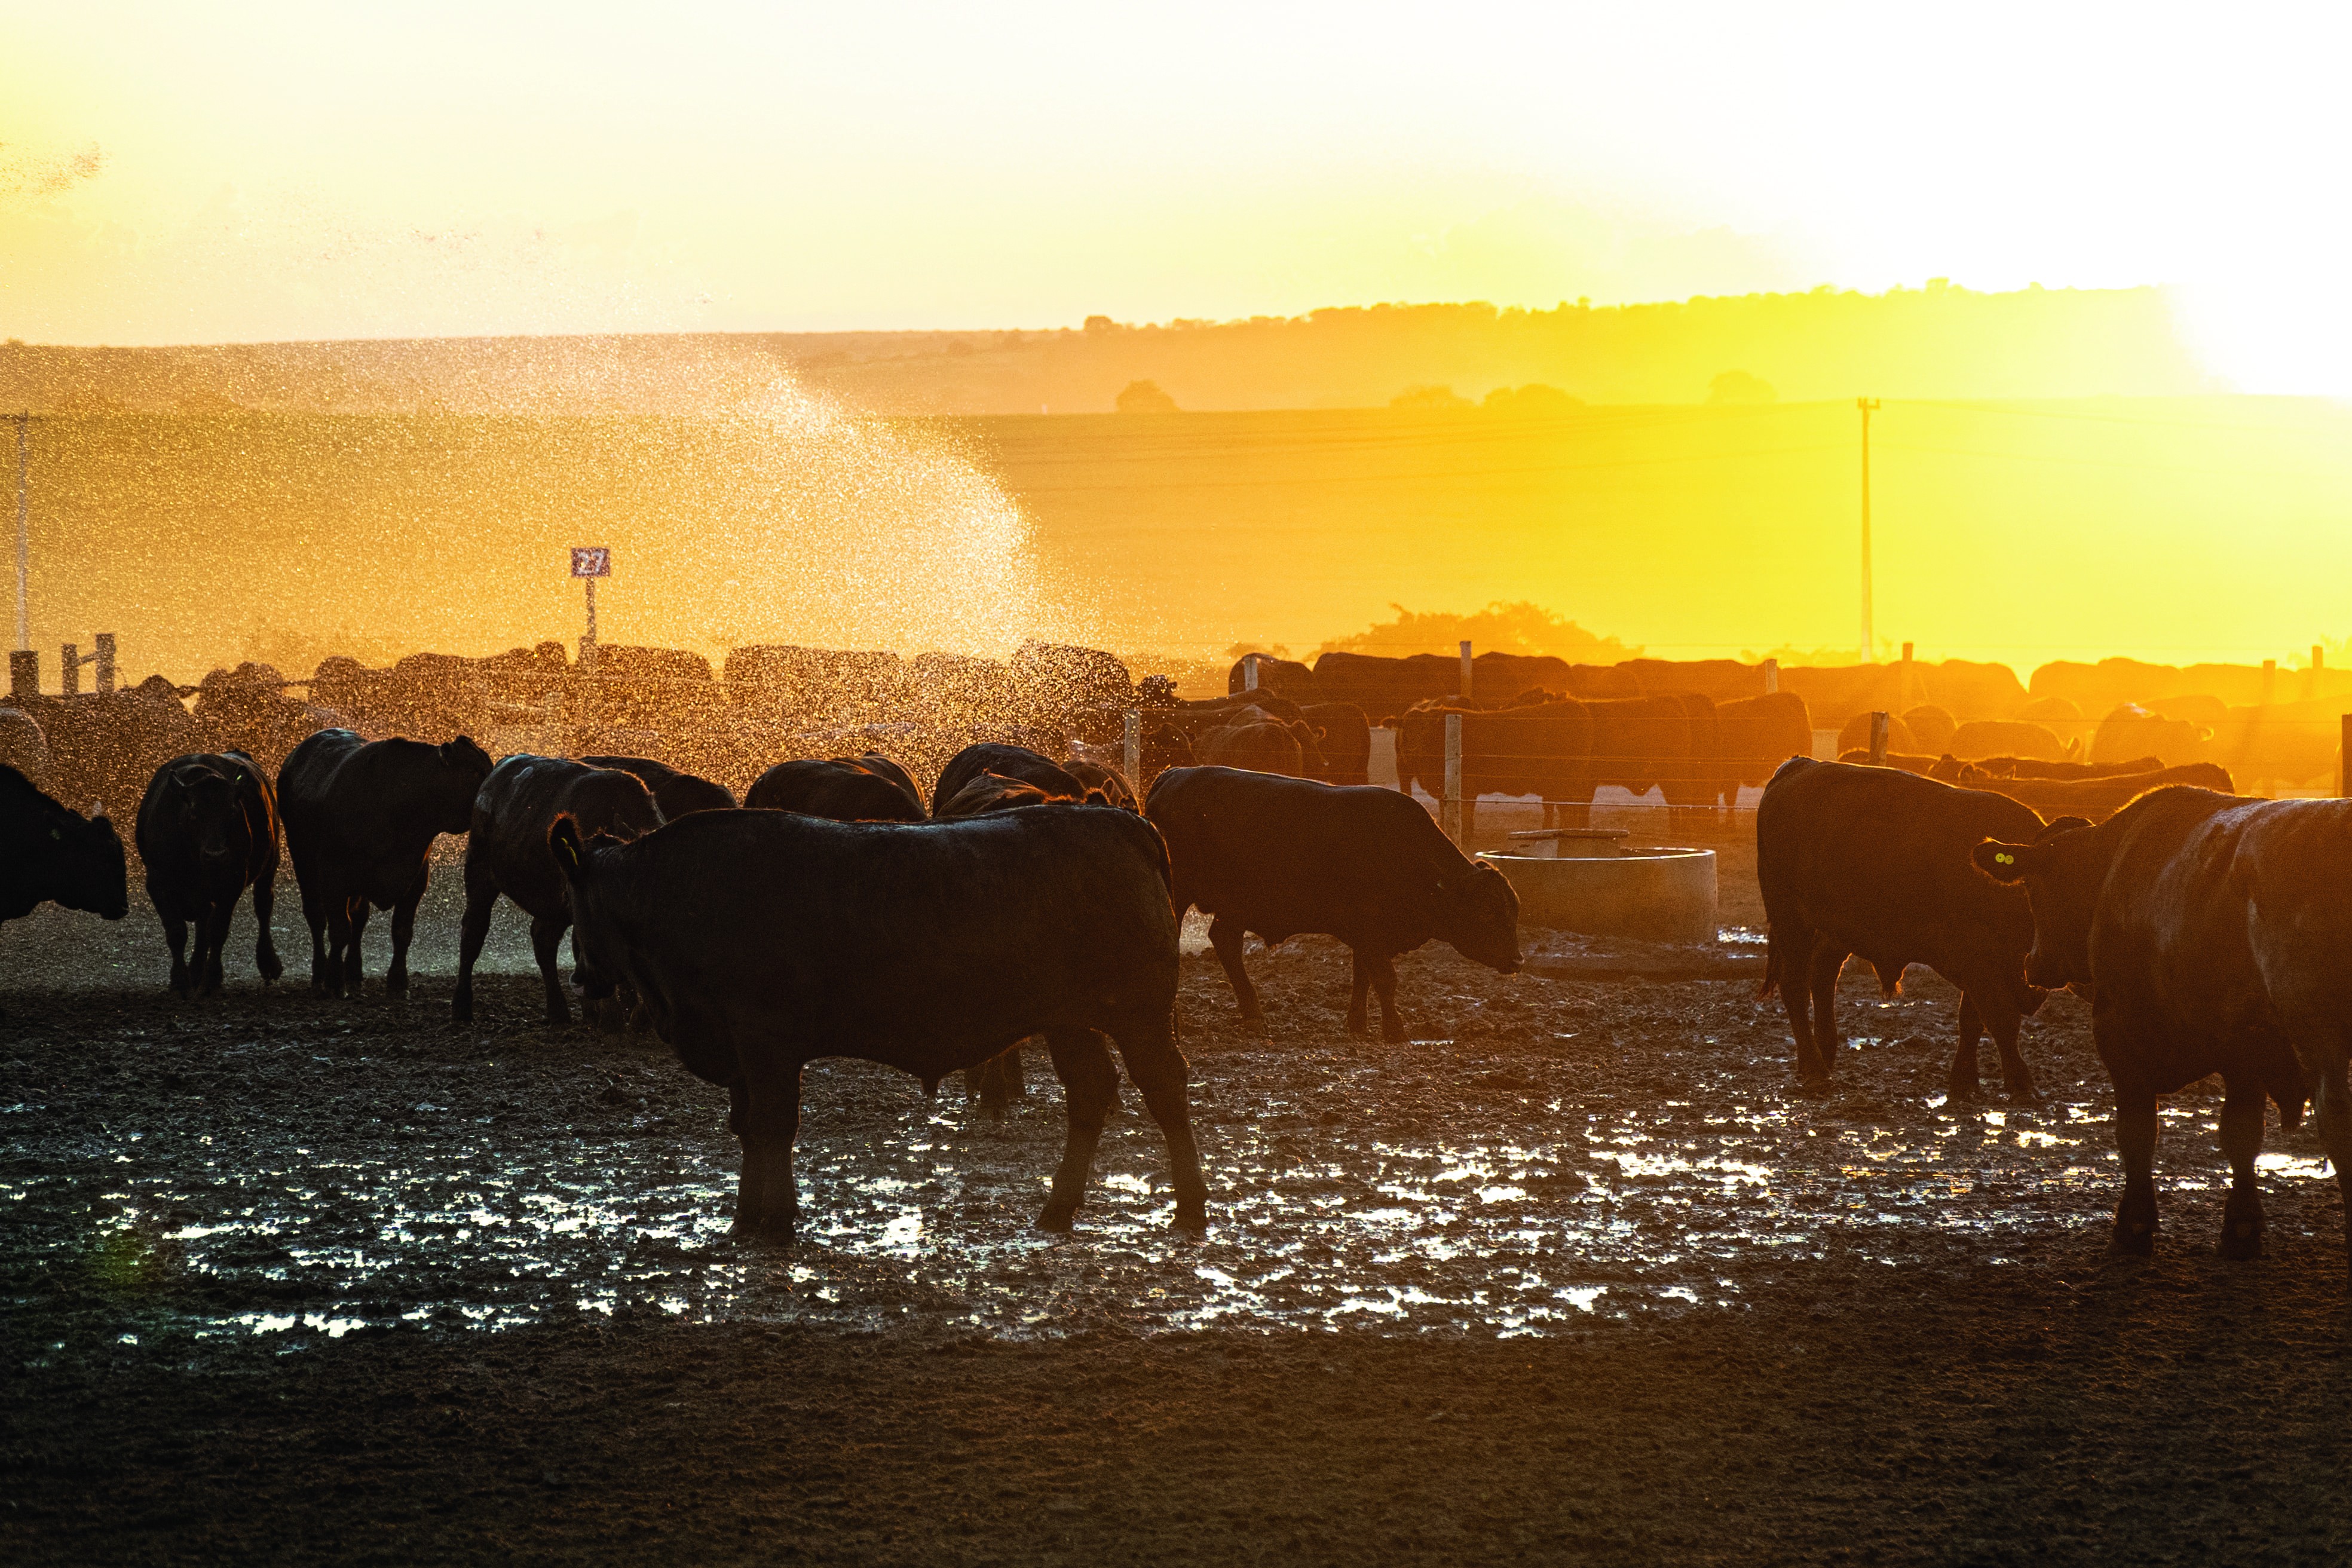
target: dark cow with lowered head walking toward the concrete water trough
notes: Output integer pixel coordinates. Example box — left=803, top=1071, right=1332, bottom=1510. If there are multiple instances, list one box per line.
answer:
left=1146, top=766, right=1520, bottom=1042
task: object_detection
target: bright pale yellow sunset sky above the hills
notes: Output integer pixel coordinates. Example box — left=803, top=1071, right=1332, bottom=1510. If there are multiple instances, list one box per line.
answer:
left=14, top=0, right=2352, bottom=393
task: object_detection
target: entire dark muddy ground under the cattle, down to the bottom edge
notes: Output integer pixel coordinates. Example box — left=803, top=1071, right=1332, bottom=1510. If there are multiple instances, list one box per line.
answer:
left=0, top=851, right=2352, bottom=1563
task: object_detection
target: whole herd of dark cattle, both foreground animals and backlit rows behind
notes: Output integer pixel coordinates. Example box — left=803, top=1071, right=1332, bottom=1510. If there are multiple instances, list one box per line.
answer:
left=0, top=647, right=2352, bottom=1255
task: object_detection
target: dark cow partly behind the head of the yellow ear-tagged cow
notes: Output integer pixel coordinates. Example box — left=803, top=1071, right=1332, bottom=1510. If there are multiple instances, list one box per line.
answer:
left=1757, top=757, right=2046, bottom=1098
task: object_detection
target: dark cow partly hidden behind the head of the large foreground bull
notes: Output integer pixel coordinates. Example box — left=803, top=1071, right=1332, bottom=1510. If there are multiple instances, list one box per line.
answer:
left=449, top=755, right=661, bottom=1027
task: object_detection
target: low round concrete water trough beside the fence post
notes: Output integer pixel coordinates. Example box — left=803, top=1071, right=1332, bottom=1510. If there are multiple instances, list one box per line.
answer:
left=1480, top=828, right=1714, bottom=943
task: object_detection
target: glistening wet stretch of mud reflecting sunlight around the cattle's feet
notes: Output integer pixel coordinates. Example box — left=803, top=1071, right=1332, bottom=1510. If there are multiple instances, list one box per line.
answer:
left=0, top=902, right=2326, bottom=1347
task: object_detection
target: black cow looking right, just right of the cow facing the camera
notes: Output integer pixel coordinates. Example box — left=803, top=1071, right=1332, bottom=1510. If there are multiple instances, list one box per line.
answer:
left=277, top=729, right=489, bottom=997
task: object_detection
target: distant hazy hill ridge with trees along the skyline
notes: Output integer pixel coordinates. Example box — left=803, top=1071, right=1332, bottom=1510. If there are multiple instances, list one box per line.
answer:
left=0, top=282, right=2218, bottom=414
